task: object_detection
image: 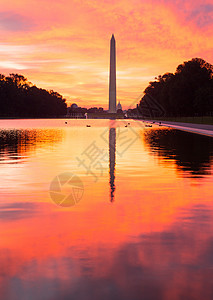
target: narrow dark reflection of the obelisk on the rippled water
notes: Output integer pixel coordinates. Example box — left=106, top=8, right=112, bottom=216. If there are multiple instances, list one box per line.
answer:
left=109, top=128, right=116, bottom=202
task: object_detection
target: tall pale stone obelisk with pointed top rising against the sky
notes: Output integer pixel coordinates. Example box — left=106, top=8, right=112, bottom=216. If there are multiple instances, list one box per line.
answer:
left=109, top=34, right=116, bottom=113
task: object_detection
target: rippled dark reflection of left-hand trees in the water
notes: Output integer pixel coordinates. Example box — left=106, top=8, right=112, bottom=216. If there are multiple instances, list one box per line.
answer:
left=0, top=129, right=62, bottom=160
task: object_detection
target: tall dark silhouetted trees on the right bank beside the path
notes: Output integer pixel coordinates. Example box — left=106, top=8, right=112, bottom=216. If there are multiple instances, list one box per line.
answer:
left=138, top=58, right=213, bottom=117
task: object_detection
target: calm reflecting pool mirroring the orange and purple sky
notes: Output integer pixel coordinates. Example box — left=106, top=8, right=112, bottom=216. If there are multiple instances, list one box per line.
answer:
left=0, top=119, right=213, bottom=300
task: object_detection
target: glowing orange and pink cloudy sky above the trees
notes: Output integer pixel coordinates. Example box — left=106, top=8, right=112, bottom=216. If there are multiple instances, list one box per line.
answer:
left=0, top=0, right=213, bottom=108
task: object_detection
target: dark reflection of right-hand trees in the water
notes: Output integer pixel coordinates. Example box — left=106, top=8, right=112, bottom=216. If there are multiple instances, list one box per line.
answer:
left=144, top=129, right=213, bottom=177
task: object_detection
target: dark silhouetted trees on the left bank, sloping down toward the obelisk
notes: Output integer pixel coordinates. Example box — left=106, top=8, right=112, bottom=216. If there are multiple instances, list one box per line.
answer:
left=0, top=74, right=67, bottom=118
